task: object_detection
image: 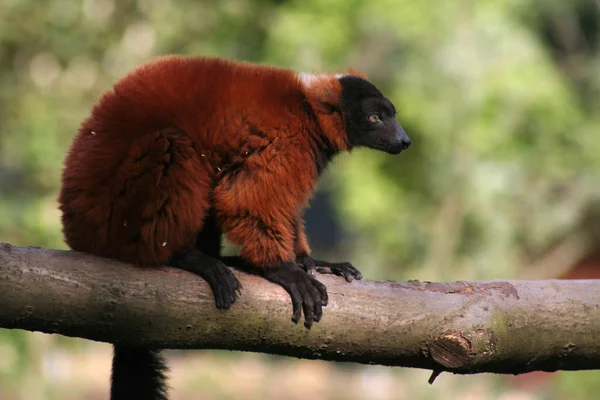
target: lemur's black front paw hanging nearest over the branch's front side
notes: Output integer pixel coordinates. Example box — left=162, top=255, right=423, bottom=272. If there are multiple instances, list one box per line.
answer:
left=262, top=262, right=328, bottom=329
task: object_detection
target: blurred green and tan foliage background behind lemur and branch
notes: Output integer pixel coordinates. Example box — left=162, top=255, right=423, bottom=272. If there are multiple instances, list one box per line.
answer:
left=0, top=0, right=600, bottom=400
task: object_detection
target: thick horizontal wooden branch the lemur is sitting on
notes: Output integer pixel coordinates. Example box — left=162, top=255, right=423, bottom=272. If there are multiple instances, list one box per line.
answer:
left=0, top=244, right=600, bottom=374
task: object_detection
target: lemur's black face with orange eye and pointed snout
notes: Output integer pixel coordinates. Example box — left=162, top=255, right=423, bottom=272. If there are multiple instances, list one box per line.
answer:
left=340, top=75, right=410, bottom=154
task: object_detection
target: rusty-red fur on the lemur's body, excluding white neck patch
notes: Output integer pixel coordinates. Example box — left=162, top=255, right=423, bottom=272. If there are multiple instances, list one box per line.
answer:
left=59, top=57, right=348, bottom=267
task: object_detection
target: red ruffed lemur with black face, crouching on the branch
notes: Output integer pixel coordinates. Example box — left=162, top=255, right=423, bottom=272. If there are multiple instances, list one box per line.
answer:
left=59, top=56, right=410, bottom=400
